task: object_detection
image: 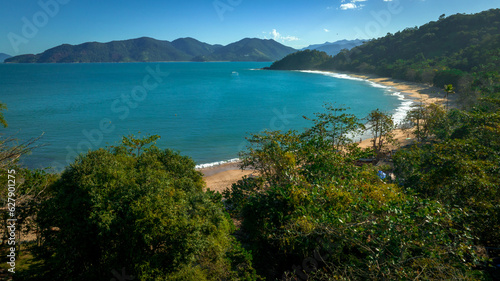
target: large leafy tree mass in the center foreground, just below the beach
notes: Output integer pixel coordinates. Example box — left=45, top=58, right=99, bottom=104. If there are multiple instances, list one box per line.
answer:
left=224, top=104, right=480, bottom=280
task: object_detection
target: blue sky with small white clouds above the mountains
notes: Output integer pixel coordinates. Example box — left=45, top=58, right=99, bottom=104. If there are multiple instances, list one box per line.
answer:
left=0, top=0, right=500, bottom=55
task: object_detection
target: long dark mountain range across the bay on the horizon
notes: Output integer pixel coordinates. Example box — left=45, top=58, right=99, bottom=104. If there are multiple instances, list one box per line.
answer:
left=6, top=37, right=295, bottom=63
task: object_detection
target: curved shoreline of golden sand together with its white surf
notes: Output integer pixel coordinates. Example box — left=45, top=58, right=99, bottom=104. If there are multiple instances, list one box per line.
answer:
left=203, top=70, right=454, bottom=192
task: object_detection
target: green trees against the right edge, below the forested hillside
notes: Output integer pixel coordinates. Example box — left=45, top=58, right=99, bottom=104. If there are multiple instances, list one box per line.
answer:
left=394, top=106, right=500, bottom=247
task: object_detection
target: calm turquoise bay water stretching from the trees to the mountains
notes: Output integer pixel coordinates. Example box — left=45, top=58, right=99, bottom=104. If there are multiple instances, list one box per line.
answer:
left=0, top=62, right=407, bottom=170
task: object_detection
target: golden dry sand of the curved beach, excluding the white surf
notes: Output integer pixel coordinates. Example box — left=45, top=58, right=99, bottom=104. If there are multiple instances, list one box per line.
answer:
left=199, top=74, right=453, bottom=192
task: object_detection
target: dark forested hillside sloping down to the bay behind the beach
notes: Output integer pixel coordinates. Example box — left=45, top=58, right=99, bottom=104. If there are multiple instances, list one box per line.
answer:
left=270, top=9, right=500, bottom=104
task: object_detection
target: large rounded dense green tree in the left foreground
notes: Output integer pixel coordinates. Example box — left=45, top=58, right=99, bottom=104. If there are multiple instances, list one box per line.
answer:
left=37, top=136, right=257, bottom=280
